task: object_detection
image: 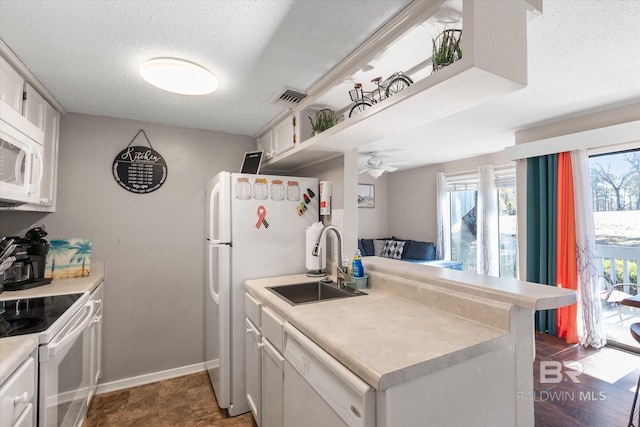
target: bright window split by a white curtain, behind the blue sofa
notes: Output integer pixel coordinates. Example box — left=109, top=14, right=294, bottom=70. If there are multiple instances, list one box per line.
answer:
left=447, top=166, right=518, bottom=278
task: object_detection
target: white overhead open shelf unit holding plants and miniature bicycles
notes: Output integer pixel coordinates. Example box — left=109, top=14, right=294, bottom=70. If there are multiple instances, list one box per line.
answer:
left=258, top=0, right=542, bottom=172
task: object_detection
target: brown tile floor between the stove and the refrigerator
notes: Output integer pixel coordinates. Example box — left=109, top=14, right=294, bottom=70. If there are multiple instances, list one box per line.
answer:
left=83, top=372, right=257, bottom=427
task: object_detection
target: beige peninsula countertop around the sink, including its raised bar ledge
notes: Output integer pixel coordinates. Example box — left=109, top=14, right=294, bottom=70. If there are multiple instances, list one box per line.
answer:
left=245, top=257, right=576, bottom=390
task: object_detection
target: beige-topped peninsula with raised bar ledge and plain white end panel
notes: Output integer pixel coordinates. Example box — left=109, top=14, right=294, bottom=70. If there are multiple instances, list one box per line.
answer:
left=245, top=257, right=576, bottom=426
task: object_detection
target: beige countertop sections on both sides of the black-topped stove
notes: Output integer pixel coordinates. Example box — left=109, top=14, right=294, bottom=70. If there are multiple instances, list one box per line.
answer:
left=0, top=261, right=105, bottom=385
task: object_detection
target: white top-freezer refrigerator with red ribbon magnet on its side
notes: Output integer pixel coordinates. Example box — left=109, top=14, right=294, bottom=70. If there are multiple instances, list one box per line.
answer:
left=204, top=172, right=320, bottom=416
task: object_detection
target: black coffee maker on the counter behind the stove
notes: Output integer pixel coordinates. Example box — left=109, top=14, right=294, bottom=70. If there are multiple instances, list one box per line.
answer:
left=0, top=224, right=51, bottom=292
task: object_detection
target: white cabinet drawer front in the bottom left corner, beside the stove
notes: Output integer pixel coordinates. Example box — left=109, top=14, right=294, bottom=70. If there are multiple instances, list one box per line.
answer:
left=0, top=357, right=36, bottom=426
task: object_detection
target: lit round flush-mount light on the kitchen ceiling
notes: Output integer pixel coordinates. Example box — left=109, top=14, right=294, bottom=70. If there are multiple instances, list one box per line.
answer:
left=140, top=58, right=218, bottom=95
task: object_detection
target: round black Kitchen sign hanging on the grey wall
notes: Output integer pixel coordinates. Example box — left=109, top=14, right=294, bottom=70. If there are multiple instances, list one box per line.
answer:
left=113, top=129, right=167, bottom=193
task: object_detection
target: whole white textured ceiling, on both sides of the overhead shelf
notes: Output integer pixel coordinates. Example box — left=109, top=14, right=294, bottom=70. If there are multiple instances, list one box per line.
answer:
left=0, top=0, right=640, bottom=169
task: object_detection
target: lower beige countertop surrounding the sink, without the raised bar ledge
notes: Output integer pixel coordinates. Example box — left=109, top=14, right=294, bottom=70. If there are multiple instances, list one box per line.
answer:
left=245, top=275, right=511, bottom=390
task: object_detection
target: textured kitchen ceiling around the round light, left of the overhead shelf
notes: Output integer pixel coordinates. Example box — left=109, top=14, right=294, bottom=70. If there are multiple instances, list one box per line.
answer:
left=0, top=0, right=409, bottom=136
